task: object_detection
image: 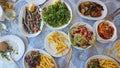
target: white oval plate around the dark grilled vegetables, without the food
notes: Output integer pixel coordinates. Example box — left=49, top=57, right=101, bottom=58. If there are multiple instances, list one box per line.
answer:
left=76, top=0, right=107, bottom=20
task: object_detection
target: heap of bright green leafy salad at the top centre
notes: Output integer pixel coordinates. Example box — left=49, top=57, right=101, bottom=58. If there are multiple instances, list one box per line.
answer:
left=42, top=2, right=71, bottom=28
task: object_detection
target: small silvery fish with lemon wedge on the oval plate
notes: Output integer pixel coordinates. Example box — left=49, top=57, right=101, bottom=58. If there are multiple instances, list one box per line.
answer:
left=22, top=4, right=41, bottom=34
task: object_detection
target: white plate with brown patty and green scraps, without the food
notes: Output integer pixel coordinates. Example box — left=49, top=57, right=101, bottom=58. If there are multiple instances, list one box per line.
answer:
left=0, top=35, right=25, bottom=63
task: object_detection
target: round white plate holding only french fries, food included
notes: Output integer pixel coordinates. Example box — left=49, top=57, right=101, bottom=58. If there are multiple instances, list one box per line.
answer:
left=44, top=31, right=71, bottom=57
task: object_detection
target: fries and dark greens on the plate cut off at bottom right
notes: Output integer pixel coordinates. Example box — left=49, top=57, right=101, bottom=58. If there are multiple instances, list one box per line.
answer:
left=87, top=58, right=119, bottom=68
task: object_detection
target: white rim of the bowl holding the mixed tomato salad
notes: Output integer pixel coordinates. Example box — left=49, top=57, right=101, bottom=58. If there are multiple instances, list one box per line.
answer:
left=68, top=22, right=96, bottom=50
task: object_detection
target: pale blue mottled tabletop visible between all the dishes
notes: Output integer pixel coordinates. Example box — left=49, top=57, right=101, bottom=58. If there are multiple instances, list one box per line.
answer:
left=0, top=0, right=120, bottom=68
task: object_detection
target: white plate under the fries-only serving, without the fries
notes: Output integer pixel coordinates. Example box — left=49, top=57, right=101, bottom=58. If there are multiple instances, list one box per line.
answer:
left=44, top=31, right=71, bottom=57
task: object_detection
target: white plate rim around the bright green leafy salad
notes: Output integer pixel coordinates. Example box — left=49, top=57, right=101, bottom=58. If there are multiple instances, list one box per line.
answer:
left=42, top=0, right=72, bottom=30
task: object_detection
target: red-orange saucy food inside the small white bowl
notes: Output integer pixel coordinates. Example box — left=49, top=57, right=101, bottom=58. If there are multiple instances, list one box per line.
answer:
left=97, top=21, right=114, bottom=39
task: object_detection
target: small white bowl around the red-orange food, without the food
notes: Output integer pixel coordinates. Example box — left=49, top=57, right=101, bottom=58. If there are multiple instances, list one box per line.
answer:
left=93, top=20, right=117, bottom=43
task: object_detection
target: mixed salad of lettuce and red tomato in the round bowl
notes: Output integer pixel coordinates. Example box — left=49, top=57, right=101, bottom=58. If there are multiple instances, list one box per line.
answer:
left=70, top=24, right=96, bottom=49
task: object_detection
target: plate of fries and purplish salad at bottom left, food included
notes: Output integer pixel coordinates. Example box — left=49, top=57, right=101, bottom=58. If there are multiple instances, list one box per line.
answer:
left=23, top=49, right=57, bottom=68
